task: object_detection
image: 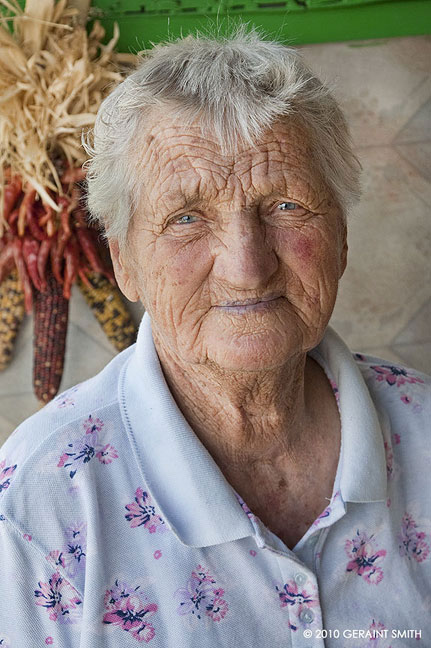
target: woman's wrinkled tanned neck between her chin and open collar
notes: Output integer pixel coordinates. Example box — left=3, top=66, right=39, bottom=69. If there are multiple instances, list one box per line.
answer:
left=155, top=338, right=329, bottom=475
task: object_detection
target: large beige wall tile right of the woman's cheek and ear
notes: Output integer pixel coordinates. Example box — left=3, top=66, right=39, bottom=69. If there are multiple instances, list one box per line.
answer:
left=333, top=147, right=431, bottom=349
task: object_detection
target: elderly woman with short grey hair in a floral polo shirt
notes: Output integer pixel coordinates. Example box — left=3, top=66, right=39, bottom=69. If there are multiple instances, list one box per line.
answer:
left=0, top=30, right=431, bottom=648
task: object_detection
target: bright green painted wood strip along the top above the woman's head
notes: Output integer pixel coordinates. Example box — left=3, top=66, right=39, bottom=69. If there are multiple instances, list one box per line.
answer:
left=88, top=0, right=431, bottom=52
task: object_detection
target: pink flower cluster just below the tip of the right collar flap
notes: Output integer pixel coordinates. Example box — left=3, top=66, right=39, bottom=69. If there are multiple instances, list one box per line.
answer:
left=344, top=529, right=386, bottom=585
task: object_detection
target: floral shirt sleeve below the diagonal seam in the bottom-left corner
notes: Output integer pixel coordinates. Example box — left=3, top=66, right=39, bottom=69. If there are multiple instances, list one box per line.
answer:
left=0, top=514, right=83, bottom=648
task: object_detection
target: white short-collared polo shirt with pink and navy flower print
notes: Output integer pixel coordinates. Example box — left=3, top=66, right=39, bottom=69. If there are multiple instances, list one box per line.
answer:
left=0, top=315, right=431, bottom=648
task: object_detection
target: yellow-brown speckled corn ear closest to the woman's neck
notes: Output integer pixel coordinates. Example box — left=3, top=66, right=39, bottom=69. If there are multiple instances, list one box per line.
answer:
left=79, top=272, right=137, bottom=351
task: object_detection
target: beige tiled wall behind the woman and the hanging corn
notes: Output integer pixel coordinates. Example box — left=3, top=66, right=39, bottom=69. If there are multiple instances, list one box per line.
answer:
left=0, top=36, right=431, bottom=445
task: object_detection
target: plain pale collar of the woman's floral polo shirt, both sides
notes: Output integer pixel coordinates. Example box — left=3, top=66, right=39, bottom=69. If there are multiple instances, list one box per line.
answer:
left=119, top=313, right=386, bottom=547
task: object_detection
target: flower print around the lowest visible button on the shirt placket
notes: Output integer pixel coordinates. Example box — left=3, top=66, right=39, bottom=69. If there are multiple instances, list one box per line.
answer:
left=275, top=579, right=321, bottom=632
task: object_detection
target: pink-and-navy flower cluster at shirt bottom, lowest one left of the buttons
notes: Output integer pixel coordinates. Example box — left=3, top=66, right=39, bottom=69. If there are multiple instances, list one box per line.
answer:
left=103, top=579, right=158, bottom=643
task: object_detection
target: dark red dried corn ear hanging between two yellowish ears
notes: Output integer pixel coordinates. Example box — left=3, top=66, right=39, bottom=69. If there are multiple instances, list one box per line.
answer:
left=33, top=272, right=69, bottom=403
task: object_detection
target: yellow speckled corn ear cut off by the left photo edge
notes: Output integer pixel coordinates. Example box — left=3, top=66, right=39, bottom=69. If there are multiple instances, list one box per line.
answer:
left=0, top=270, right=24, bottom=371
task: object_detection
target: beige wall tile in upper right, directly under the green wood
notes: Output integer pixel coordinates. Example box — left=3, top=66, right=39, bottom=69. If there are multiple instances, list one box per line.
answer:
left=302, top=36, right=431, bottom=146
